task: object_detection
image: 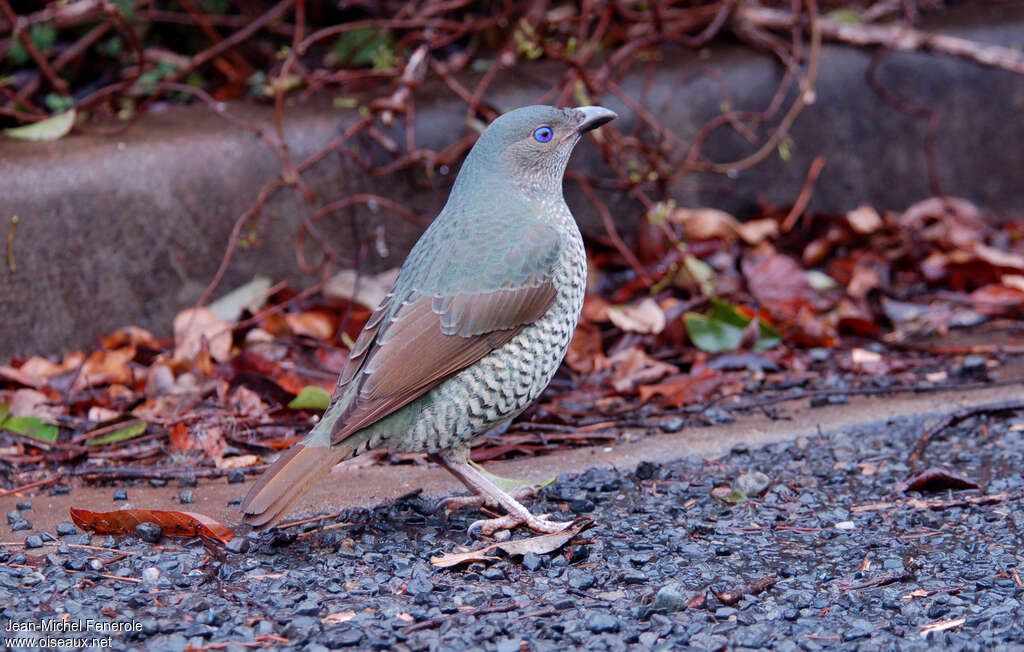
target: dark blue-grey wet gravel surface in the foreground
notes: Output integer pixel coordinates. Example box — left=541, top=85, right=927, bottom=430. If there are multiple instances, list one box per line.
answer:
left=0, top=415, right=1024, bottom=652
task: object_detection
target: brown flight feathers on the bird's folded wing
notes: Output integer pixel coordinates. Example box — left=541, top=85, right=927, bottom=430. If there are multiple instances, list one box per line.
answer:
left=331, top=279, right=555, bottom=444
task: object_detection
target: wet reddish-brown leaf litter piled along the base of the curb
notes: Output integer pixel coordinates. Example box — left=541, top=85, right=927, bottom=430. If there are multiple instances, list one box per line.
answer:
left=0, top=198, right=1024, bottom=544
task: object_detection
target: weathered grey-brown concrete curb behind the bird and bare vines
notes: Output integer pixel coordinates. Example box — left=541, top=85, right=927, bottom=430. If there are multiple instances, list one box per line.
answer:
left=0, top=3, right=1024, bottom=362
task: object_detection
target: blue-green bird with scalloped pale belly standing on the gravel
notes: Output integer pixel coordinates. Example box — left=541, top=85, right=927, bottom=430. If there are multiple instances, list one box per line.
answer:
left=241, top=105, right=617, bottom=535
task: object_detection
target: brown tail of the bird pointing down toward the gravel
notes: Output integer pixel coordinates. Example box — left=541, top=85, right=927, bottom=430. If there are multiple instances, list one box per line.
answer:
left=242, top=428, right=353, bottom=529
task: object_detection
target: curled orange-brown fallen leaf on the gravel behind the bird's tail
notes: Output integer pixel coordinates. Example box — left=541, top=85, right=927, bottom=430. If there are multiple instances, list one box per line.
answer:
left=71, top=507, right=234, bottom=544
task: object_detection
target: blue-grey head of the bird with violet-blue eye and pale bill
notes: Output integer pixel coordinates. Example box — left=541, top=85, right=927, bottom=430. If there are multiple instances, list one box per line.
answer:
left=460, top=105, right=617, bottom=197
